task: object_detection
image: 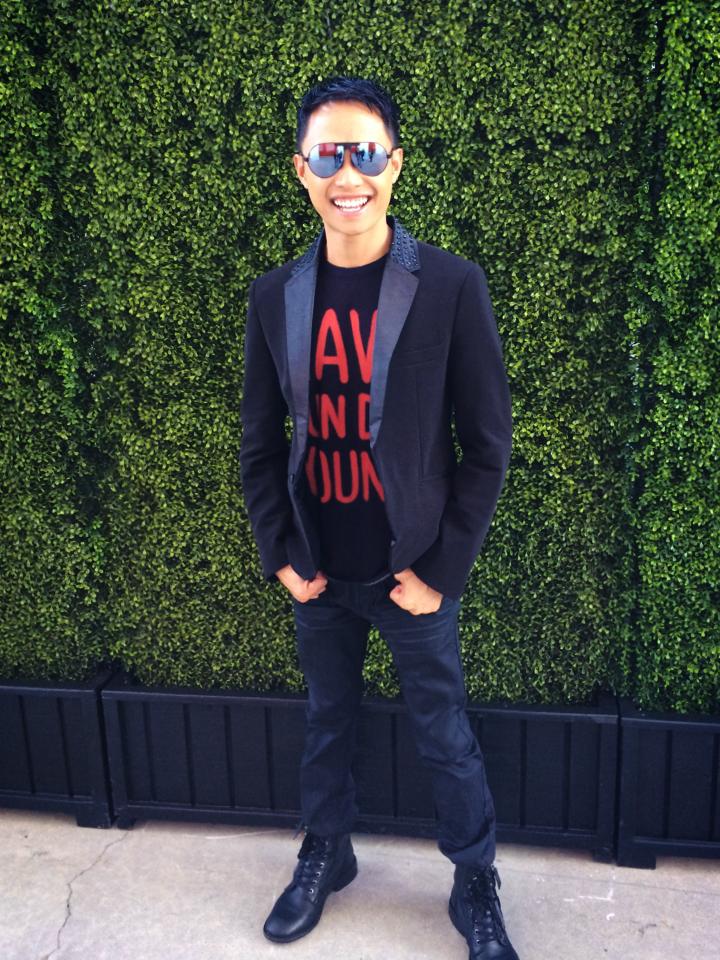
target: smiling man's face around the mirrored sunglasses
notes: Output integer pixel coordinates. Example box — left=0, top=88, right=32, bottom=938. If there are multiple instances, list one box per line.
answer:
left=293, top=100, right=403, bottom=242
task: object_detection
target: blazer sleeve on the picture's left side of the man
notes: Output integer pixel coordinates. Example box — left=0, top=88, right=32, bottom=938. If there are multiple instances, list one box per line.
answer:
left=240, top=281, right=292, bottom=581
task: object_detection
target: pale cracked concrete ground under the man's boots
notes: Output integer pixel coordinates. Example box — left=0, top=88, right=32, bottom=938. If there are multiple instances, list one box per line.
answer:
left=0, top=809, right=720, bottom=960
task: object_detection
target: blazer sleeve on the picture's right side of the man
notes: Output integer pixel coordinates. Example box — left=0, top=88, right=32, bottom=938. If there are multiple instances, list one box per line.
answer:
left=411, top=264, right=512, bottom=599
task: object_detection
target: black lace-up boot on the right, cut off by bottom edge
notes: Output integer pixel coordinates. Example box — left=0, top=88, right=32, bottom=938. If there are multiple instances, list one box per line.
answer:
left=449, top=864, right=519, bottom=960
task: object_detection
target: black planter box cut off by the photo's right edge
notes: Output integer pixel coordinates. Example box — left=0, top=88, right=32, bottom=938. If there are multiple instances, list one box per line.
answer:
left=618, top=699, right=720, bottom=868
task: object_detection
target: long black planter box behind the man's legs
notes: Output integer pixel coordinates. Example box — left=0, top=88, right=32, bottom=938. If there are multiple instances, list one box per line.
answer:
left=102, top=676, right=618, bottom=860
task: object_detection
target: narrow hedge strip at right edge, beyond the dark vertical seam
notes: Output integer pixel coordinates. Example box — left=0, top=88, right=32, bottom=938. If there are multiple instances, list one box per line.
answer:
left=628, top=0, right=720, bottom=712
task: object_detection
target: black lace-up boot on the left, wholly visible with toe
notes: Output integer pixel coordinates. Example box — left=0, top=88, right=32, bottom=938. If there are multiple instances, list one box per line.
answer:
left=263, top=831, right=357, bottom=943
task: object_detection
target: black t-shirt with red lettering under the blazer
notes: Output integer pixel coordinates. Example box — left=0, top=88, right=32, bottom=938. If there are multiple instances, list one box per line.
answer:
left=305, top=244, right=391, bottom=581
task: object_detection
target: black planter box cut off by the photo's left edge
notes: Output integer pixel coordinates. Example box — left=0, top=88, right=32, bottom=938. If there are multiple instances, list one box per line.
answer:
left=0, top=670, right=113, bottom=827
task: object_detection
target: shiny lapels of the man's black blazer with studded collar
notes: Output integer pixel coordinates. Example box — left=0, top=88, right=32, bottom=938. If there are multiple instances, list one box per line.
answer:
left=285, top=215, right=420, bottom=468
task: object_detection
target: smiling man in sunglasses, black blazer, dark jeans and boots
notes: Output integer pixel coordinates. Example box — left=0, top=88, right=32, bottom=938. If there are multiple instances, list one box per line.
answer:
left=240, top=77, right=517, bottom=960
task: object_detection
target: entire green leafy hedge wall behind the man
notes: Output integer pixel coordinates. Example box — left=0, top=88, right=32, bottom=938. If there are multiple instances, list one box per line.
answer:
left=0, top=0, right=720, bottom=709
